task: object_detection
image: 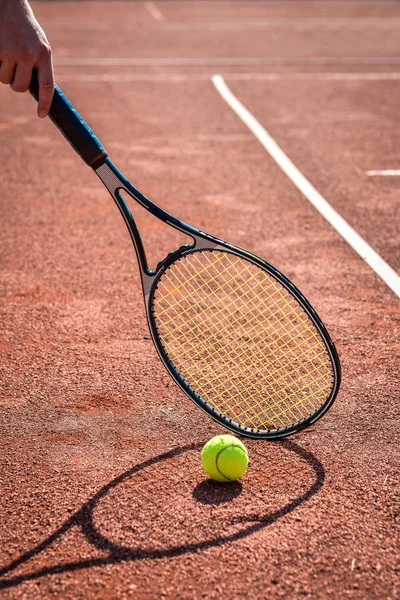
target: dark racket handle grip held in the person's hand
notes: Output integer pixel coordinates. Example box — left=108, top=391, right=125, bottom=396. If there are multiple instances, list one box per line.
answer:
left=29, top=69, right=107, bottom=169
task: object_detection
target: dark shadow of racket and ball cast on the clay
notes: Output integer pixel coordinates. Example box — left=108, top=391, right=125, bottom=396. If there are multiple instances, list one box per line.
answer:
left=0, top=440, right=325, bottom=589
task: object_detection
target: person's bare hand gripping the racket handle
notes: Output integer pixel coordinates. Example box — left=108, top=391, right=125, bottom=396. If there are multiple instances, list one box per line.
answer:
left=0, top=0, right=54, bottom=117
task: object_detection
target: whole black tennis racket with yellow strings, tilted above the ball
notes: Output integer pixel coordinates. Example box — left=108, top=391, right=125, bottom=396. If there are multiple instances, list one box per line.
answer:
left=30, top=73, right=341, bottom=439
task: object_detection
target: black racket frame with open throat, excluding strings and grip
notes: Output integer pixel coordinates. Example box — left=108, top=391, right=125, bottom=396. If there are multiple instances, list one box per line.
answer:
left=94, top=157, right=341, bottom=440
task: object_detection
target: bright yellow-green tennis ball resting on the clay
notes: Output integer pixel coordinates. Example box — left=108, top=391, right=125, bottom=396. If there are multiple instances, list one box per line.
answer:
left=201, top=435, right=249, bottom=482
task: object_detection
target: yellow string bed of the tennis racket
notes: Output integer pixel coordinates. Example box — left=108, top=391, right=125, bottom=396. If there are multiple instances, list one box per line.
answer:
left=152, top=250, right=333, bottom=429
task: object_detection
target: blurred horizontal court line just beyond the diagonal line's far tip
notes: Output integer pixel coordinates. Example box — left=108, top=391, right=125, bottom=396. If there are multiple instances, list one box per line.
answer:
left=55, top=56, right=400, bottom=67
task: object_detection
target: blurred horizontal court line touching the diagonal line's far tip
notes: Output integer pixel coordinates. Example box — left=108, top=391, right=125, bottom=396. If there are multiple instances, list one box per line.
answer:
left=57, top=72, right=400, bottom=83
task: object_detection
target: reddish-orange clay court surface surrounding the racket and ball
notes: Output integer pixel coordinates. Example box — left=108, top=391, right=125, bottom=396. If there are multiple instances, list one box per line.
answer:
left=0, top=0, right=400, bottom=600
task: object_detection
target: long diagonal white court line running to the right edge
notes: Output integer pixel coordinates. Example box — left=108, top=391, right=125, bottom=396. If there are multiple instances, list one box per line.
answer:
left=212, top=75, right=400, bottom=297
